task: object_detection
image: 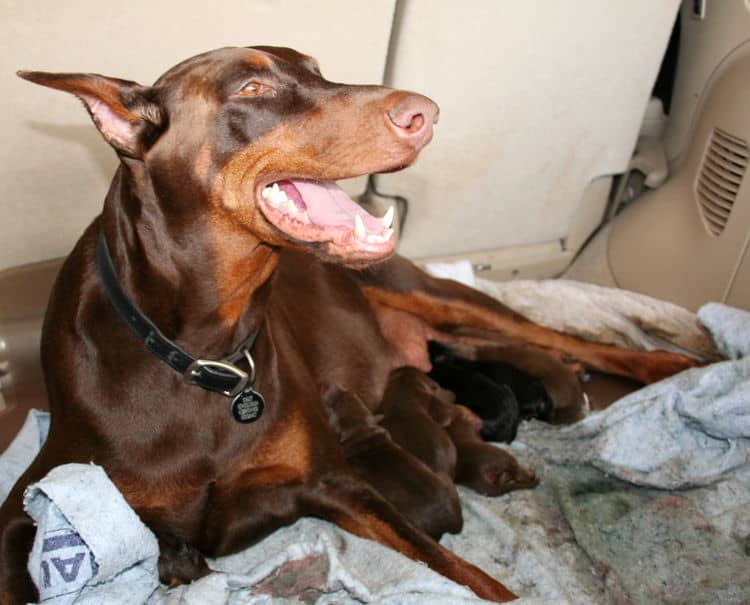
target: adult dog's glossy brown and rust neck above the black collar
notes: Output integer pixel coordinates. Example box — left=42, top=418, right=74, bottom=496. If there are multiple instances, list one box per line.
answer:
left=101, top=162, right=279, bottom=357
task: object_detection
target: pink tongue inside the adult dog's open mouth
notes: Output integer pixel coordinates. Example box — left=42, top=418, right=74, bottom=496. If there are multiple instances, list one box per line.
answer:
left=278, top=179, right=384, bottom=233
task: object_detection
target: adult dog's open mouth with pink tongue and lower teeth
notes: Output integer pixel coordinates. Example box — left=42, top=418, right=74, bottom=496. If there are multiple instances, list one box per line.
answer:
left=258, top=178, right=395, bottom=260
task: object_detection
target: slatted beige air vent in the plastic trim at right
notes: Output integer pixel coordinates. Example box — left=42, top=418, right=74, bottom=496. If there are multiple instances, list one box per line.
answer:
left=695, top=128, right=750, bottom=235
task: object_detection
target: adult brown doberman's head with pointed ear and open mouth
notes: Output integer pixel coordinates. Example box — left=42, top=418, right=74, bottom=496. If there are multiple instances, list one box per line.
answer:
left=19, top=47, right=438, bottom=266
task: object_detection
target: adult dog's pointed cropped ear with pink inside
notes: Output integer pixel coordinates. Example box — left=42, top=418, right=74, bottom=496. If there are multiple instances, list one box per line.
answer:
left=17, top=71, right=167, bottom=158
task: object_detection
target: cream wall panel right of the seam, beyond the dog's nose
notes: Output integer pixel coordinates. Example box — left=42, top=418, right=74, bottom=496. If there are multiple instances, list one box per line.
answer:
left=378, top=0, right=679, bottom=258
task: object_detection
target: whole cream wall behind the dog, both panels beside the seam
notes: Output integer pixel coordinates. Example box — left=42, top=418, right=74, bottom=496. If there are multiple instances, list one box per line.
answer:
left=0, top=0, right=678, bottom=275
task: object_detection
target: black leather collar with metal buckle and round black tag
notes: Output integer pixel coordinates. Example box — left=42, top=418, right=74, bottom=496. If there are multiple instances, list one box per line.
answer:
left=96, top=231, right=262, bottom=406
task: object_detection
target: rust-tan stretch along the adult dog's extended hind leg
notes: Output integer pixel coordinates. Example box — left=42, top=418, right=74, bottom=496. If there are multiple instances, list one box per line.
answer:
left=363, top=287, right=697, bottom=384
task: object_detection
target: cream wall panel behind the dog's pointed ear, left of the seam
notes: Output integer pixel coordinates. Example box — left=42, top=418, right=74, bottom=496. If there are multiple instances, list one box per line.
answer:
left=0, top=0, right=395, bottom=269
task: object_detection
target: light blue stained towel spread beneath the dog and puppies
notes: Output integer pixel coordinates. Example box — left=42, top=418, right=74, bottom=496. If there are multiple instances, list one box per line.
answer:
left=0, top=306, right=750, bottom=605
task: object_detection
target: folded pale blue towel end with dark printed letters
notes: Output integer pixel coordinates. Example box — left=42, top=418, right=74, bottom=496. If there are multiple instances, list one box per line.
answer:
left=24, top=464, right=159, bottom=605
